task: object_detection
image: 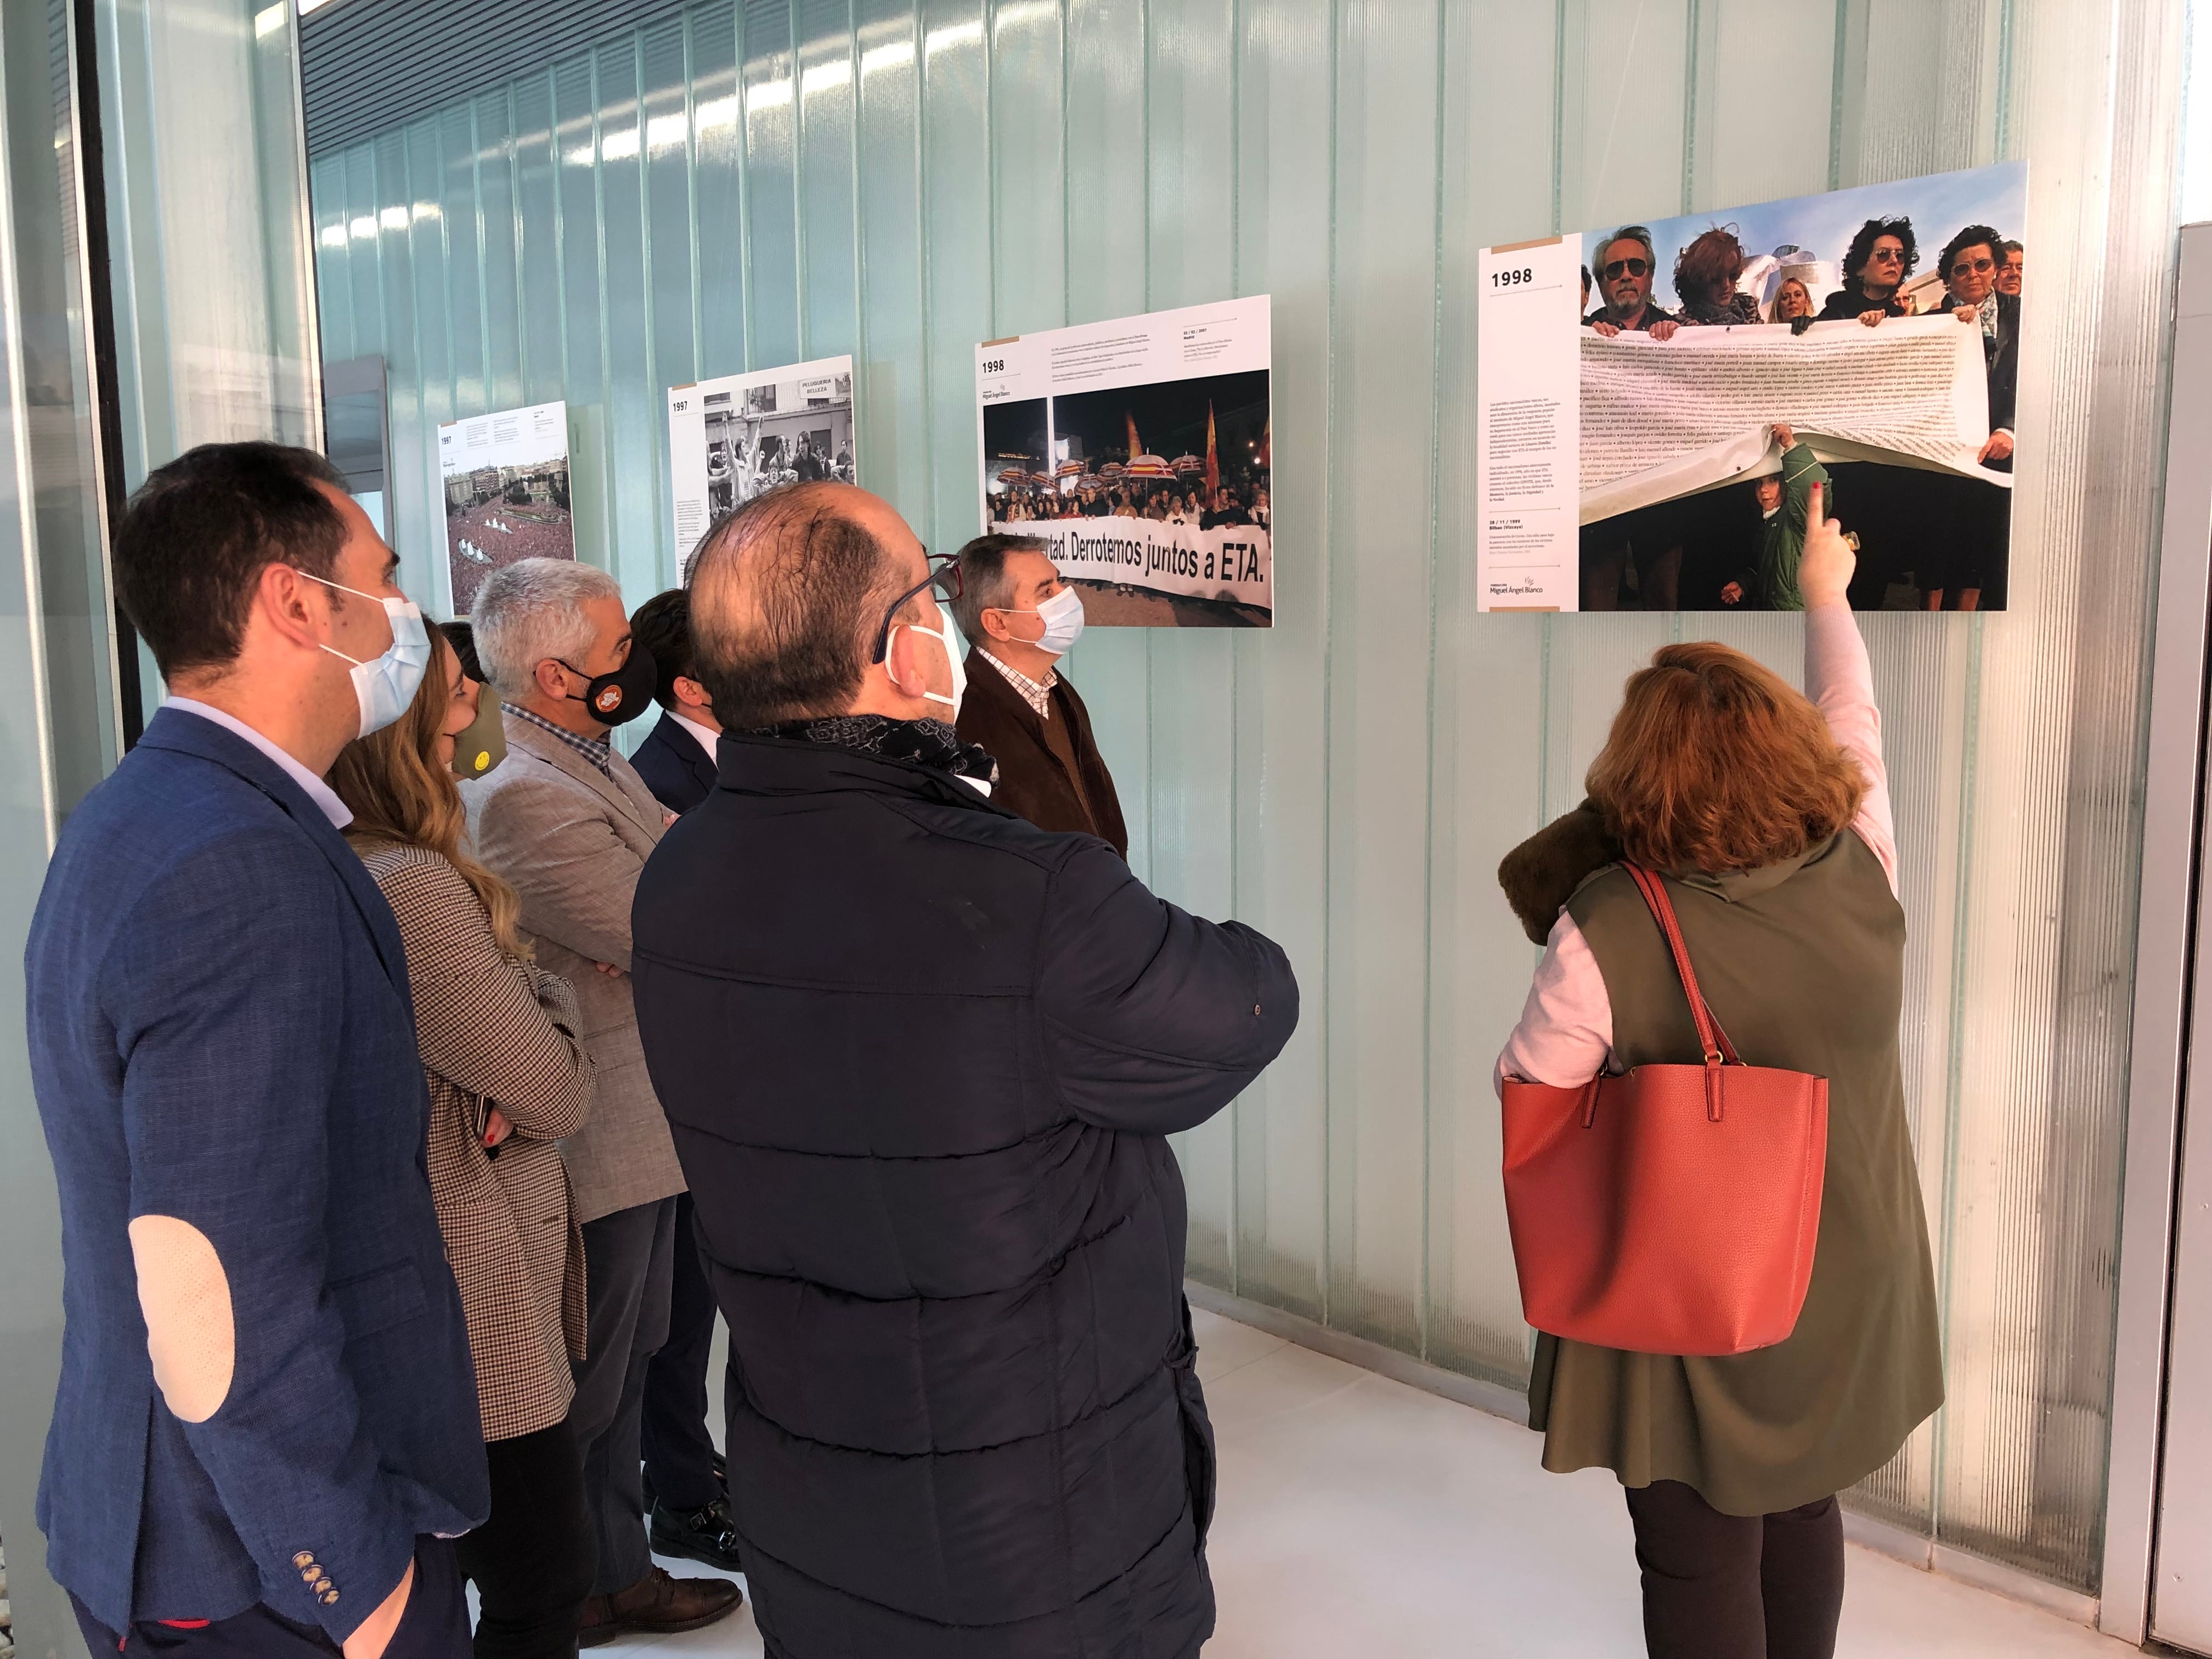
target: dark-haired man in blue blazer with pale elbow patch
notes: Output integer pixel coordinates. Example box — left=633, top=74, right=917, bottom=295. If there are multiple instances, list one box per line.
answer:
left=26, top=444, right=487, bottom=1659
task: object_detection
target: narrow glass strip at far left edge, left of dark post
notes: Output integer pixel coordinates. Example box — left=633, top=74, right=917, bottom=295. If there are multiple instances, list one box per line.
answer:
left=0, top=0, right=122, bottom=1655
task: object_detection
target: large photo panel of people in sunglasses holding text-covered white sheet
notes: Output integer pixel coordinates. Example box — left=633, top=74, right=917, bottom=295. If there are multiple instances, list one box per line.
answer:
left=1477, top=161, right=2026, bottom=611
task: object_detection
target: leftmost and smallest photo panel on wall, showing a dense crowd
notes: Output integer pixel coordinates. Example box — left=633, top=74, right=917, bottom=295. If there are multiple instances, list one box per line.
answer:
left=438, top=403, right=575, bottom=617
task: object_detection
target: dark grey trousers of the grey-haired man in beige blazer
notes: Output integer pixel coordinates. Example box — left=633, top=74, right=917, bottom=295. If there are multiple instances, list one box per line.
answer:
left=568, top=1199, right=677, bottom=1595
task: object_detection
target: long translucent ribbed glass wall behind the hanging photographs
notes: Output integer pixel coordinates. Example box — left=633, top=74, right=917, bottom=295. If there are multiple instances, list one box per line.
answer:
left=312, top=0, right=2181, bottom=1586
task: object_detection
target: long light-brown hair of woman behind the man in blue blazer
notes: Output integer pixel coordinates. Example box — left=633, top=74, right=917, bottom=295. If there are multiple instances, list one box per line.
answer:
left=330, top=628, right=531, bottom=962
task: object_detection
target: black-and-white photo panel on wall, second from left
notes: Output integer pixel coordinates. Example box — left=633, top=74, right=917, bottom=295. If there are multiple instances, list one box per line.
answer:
left=668, top=356, right=858, bottom=564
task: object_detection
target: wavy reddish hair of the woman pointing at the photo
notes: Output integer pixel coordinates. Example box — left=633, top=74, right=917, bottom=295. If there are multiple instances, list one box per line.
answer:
left=1586, top=639, right=1867, bottom=874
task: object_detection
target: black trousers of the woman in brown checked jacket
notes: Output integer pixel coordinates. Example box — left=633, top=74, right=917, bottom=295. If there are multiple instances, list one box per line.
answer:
left=458, top=1423, right=600, bottom=1659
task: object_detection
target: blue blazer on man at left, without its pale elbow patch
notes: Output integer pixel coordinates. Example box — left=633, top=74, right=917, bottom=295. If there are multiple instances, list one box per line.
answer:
left=24, top=710, right=489, bottom=1641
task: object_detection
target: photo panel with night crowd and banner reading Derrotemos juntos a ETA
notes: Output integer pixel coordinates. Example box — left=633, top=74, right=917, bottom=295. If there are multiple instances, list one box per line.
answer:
left=978, top=296, right=1274, bottom=628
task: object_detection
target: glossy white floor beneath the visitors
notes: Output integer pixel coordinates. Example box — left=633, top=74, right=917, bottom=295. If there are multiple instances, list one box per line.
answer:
left=597, top=1312, right=2132, bottom=1659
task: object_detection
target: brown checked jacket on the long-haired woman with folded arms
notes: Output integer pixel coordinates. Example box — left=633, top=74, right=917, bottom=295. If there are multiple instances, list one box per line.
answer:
left=358, top=843, right=593, bottom=1440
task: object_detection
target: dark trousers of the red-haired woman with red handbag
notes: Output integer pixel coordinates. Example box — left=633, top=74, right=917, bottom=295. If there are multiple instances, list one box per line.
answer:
left=1626, top=1480, right=1843, bottom=1659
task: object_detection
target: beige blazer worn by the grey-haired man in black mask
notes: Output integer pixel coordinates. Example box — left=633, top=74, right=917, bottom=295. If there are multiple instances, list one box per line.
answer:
left=460, top=714, right=684, bottom=1221
